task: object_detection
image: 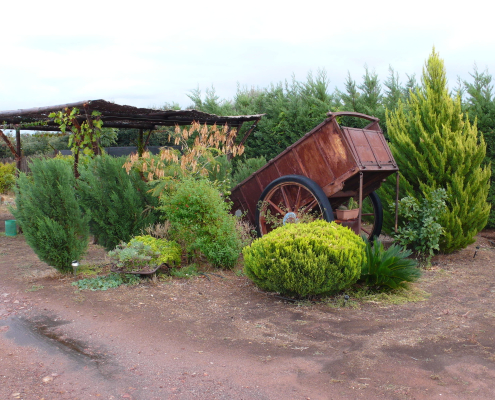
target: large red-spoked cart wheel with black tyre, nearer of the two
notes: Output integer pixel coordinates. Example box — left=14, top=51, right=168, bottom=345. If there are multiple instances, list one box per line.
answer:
left=255, top=175, right=334, bottom=237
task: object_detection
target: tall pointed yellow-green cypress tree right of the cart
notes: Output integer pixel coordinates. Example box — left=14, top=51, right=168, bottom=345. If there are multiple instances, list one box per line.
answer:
left=384, top=49, right=490, bottom=253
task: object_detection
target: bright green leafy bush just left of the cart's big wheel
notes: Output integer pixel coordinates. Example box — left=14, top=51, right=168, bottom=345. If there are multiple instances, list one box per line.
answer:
left=161, top=177, right=242, bottom=268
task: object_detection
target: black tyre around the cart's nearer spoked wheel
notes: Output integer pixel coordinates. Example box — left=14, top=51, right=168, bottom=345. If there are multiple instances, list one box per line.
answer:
left=255, top=175, right=334, bottom=237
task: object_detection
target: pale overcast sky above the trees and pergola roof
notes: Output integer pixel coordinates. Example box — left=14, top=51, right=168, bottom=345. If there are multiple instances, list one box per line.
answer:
left=0, top=0, right=495, bottom=110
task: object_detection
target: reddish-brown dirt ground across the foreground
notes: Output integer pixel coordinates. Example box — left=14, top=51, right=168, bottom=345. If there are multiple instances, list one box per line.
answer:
left=0, top=200, right=495, bottom=400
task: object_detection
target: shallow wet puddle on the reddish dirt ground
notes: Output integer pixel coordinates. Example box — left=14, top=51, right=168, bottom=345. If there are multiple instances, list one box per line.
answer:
left=0, top=315, right=114, bottom=379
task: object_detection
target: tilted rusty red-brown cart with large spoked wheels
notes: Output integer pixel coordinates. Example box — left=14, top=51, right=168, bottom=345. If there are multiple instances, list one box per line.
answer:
left=231, top=112, right=399, bottom=238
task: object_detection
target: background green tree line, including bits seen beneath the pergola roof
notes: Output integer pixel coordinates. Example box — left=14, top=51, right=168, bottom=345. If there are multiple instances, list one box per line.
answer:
left=0, top=53, right=495, bottom=233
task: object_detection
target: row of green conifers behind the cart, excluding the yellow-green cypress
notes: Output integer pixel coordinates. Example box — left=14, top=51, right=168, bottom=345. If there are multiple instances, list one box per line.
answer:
left=188, top=66, right=495, bottom=165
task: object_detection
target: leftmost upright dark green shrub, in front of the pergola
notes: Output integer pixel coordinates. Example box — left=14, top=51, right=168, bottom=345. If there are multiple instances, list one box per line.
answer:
left=12, top=159, right=88, bottom=273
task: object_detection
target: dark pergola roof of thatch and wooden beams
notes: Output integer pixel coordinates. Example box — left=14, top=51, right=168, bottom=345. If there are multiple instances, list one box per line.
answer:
left=0, top=100, right=264, bottom=169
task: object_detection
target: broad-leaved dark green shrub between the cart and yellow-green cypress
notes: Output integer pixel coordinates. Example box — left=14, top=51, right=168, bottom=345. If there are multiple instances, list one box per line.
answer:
left=391, top=189, right=447, bottom=263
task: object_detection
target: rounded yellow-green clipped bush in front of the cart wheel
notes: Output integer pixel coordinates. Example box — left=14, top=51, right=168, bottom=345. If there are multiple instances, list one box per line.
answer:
left=243, top=221, right=366, bottom=297
